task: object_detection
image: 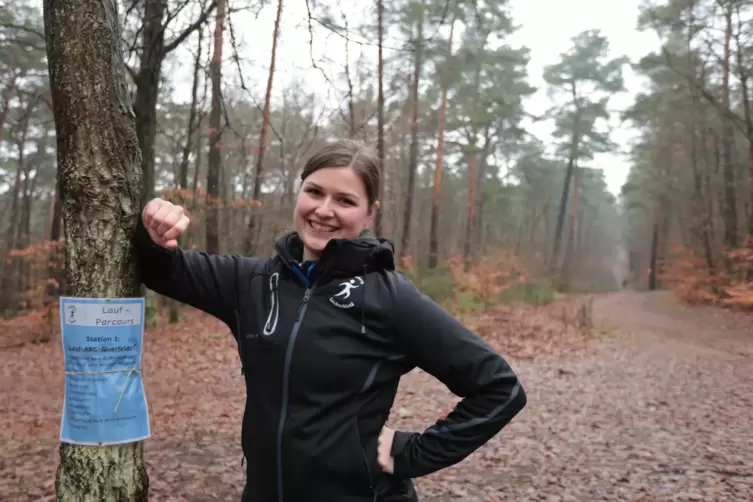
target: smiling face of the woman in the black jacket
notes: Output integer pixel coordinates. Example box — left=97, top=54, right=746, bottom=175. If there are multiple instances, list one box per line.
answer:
left=294, top=167, right=378, bottom=260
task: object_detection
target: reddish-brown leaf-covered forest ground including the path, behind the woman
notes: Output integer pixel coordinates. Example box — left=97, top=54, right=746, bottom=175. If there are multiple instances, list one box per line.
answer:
left=0, top=292, right=753, bottom=502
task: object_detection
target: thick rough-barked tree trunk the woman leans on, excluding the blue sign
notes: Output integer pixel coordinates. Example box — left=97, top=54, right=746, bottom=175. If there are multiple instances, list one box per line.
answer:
left=44, top=0, right=149, bottom=502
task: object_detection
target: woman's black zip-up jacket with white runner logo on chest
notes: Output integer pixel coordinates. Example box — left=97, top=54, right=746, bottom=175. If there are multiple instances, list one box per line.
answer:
left=135, top=225, right=526, bottom=502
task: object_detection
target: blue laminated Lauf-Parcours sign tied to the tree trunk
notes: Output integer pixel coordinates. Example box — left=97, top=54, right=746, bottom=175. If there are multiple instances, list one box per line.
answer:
left=60, top=297, right=151, bottom=445
